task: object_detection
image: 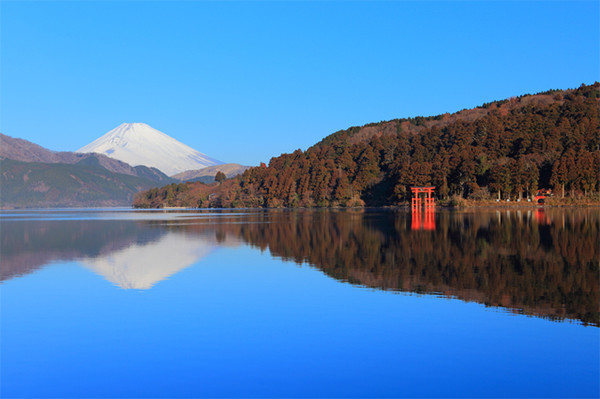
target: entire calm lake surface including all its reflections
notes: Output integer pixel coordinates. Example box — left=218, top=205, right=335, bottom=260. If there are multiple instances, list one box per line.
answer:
left=0, top=208, right=600, bottom=398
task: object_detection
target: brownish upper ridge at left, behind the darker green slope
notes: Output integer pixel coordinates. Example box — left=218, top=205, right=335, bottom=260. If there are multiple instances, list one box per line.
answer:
left=0, top=133, right=172, bottom=184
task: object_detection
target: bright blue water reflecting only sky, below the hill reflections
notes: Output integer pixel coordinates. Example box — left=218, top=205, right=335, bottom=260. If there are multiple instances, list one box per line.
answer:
left=0, top=211, right=600, bottom=398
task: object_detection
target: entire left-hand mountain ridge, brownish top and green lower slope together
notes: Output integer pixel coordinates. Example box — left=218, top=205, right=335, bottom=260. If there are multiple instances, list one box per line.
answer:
left=0, top=133, right=175, bottom=209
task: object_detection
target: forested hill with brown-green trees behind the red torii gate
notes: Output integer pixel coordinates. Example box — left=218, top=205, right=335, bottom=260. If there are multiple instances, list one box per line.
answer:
left=134, top=82, right=600, bottom=211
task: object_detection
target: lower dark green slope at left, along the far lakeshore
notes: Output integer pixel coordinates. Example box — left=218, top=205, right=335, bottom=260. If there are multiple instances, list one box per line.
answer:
left=0, top=158, right=166, bottom=209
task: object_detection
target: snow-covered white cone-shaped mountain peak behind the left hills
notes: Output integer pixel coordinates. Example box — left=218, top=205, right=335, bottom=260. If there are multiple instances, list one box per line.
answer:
left=77, top=123, right=223, bottom=176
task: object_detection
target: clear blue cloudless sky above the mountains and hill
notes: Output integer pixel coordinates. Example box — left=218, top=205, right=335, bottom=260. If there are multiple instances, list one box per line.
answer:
left=0, top=0, right=600, bottom=165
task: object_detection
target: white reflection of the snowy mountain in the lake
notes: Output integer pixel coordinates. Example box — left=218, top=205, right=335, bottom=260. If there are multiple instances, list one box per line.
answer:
left=81, top=233, right=215, bottom=289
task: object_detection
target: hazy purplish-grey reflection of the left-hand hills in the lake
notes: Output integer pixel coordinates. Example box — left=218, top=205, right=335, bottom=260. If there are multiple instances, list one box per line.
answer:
left=0, top=220, right=163, bottom=281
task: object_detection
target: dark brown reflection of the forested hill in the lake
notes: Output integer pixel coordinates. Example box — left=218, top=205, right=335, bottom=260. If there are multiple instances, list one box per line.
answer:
left=176, top=211, right=600, bottom=325
